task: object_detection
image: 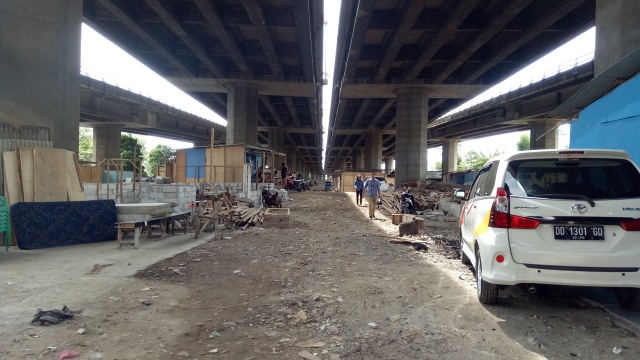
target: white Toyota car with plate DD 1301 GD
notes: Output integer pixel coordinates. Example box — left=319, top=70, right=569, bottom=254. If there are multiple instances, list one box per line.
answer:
left=455, top=149, right=640, bottom=310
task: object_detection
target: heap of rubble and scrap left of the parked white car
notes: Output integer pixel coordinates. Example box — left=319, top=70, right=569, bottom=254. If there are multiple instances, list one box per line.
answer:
left=380, top=182, right=468, bottom=214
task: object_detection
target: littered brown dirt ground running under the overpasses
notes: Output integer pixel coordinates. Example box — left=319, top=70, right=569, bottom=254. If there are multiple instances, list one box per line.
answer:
left=0, top=187, right=640, bottom=360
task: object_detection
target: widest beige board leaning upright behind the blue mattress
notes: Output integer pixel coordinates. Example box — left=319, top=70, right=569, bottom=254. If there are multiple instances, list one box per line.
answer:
left=33, top=148, right=67, bottom=201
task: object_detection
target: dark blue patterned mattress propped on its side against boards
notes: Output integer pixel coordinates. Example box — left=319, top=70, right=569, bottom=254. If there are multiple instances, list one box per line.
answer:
left=11, top=200, right=118, bottom=250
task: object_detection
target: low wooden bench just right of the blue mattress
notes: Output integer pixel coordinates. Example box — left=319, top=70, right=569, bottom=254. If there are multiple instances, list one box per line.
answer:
left=116, top=211, right=191, bottom=249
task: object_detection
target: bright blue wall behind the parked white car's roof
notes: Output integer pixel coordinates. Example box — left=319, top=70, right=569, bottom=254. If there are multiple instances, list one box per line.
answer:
left=569, top=75, right=640, bottom=164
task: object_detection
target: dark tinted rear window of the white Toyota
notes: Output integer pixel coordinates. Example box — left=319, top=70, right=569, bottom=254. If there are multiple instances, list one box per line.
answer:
left=504, top=158, right=640, bottom=199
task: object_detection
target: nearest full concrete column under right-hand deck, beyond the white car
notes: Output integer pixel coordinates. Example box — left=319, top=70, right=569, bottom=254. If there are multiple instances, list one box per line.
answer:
left=395, top=88, right=429, bottom=188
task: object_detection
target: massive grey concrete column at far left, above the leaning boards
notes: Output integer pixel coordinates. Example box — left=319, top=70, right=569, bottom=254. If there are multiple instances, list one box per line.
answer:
left=0, top=0, right=82, bottom=152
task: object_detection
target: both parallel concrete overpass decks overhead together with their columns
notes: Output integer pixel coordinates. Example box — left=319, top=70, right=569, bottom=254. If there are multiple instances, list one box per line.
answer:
left=0, top=0, right=640, bottom=186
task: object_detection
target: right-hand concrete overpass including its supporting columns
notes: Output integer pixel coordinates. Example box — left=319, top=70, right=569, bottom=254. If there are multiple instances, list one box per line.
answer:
left=325, top=0, right=640, bottom=183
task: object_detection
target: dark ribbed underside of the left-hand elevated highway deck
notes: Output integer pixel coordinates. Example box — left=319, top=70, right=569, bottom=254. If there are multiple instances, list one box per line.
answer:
left=83, top=0, right=323, bottom=171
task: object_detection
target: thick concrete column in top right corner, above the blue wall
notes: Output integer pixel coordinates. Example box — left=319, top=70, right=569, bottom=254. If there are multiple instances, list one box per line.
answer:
left=594, top=0, right=640, bottom=76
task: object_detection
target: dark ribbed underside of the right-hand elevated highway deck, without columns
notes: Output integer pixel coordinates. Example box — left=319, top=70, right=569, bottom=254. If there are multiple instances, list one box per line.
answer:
left=325, top=0, right=596, bottom=171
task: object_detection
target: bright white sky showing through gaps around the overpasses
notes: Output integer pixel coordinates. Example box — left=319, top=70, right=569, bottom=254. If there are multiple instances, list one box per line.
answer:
left=81, top=12, right=595, bottom=170
